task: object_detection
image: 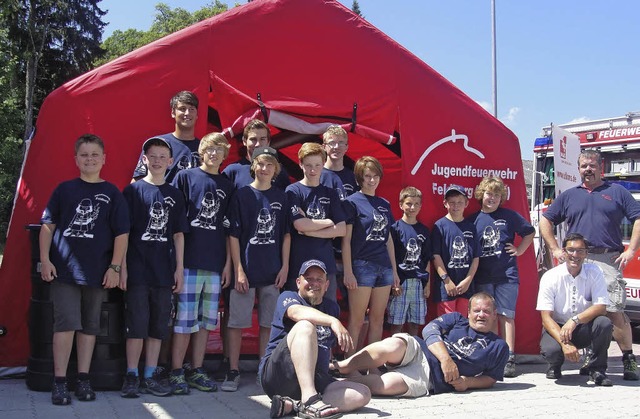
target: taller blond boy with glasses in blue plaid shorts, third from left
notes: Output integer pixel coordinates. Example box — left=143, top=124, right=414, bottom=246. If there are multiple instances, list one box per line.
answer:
left=169, top=133, right=234, bottom=394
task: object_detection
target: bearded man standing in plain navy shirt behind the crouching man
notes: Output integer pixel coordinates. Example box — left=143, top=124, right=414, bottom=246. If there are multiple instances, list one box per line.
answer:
left=539, top=150, right=640, bottom=380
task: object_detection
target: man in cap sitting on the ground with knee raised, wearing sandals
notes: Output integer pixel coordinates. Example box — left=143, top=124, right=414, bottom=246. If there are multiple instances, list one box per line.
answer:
left=258, top=259, right=371, bottom=419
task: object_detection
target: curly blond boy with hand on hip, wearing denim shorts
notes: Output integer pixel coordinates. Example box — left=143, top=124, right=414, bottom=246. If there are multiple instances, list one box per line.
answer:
left=467, top=177, right=535, bottom=377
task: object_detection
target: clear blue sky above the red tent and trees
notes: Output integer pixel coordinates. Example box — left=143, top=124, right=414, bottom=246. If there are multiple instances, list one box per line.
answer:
left=100, top=0, right=640, bottom=159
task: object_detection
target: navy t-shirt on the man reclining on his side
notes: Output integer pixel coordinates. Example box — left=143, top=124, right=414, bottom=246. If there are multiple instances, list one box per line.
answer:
left=416, top=313, right=509, bottom=394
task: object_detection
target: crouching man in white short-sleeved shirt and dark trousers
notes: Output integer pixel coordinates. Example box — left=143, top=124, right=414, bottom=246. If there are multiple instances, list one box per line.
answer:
left=536, top=233, right=613, bottom=386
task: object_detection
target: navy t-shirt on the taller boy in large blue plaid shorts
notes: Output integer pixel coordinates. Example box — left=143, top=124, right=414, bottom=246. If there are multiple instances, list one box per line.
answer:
left=173, top=167, right=234, bottom=273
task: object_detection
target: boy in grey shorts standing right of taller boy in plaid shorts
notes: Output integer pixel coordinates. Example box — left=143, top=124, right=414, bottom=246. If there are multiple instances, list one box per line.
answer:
left=220, top=147, right=291, bottom=391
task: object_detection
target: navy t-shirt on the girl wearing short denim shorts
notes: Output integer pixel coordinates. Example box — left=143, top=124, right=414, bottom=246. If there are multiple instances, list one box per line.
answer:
left=344, top=192, right=394, bottom=267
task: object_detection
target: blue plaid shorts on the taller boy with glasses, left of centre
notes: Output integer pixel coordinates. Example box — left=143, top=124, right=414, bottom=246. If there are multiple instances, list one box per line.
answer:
left=173, top=269, right=220, bottom=334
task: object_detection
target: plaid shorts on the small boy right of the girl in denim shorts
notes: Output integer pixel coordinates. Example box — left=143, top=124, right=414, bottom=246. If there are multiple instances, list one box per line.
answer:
left=387, top=278, right=427, bottom=325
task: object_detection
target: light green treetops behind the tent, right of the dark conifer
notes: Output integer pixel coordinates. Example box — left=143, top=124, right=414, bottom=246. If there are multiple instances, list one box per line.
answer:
left=95, top=0, right=228, bottom=65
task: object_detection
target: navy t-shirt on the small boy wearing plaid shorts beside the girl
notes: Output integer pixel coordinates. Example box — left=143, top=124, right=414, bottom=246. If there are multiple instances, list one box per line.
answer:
left=391, top=219, right=431, bottom=287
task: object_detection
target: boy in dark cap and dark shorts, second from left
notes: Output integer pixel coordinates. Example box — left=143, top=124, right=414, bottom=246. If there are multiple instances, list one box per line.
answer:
left=120, top=137, right=188, bottom=398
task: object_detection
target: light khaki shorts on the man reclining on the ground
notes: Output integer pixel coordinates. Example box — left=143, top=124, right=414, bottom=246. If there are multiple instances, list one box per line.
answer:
left=387, top=333, right=432, bottom=397
